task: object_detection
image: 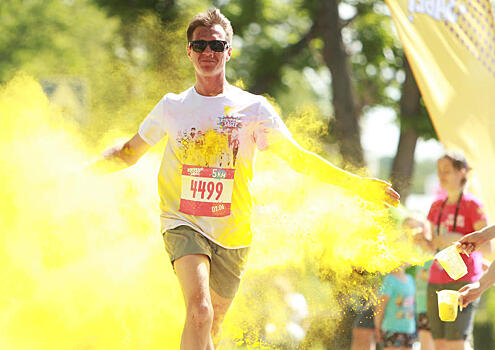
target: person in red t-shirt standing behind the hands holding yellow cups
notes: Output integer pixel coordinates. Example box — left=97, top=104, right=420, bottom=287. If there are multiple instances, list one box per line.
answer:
left=427, top=152, right=486, bottom=350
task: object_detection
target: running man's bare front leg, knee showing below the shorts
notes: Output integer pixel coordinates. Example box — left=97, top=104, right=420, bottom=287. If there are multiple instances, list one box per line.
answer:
left=174, top=255, right=214, bottom=350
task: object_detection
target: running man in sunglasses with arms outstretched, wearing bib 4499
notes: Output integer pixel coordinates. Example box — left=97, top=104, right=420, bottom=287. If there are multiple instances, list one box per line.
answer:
left=97, top=9, right=399, bottom=350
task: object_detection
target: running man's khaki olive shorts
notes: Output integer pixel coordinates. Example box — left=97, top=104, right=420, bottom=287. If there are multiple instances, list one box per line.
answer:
left=163, top=226, right=249, bottom=299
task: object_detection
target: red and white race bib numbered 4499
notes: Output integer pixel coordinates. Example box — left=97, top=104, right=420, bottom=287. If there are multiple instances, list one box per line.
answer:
left=179, top=165, right=235, bottom=217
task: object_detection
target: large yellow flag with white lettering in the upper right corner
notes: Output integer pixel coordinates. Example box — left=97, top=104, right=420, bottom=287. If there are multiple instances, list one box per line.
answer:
left=386, top=0, right=495, bottom=219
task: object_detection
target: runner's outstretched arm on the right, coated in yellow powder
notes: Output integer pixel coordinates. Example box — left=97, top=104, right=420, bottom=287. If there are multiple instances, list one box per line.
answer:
left=268, top=137, right=400, bottom=207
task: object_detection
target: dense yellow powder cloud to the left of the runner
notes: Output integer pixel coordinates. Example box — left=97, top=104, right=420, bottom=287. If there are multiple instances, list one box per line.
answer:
left=0, top=76, right=184, bottom=349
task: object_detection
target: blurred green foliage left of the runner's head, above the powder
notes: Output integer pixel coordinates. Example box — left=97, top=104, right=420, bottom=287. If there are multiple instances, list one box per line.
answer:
left=0, top=0, right=206, bottom=142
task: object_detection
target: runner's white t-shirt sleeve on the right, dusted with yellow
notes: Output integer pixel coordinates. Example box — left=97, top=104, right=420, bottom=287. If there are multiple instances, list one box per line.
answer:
left=254, top=97, right=293, bottom=151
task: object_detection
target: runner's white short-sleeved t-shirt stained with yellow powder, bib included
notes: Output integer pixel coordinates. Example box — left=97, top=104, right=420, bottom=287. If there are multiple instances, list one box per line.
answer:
left=139, top=85, right=291, bottom=248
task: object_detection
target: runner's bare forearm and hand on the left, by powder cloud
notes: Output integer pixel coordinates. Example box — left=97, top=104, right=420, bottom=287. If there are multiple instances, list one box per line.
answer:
left=88, top=134, right=151, bottom=172
